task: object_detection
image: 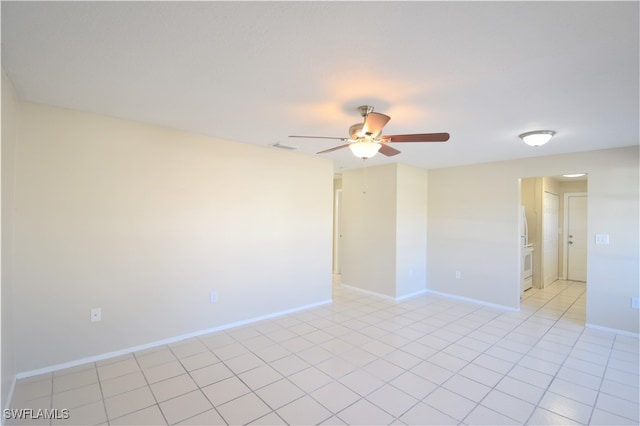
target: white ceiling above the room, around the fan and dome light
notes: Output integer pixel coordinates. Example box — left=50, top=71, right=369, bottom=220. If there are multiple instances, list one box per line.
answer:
left=2, top=1, right=640, bottom=171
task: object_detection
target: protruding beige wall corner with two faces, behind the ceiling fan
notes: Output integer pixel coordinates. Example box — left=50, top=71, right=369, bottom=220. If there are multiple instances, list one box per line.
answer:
left=341, top=164, right=428, bottom=298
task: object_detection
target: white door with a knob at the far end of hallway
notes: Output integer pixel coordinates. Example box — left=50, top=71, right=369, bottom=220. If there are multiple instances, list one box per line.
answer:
left=567, top=195, right=587, bottom=282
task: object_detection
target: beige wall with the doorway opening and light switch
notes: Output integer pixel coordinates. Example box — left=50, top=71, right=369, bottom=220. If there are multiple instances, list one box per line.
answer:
left=427, top=146, right=640, bottom=333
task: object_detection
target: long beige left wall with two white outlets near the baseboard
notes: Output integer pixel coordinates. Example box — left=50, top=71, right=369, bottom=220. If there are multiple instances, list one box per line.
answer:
left=11, top=103, right=333, bottom=372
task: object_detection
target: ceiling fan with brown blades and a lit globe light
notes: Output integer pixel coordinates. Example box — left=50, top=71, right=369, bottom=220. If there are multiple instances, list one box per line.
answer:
left=289, top=105, right=449, bottom=160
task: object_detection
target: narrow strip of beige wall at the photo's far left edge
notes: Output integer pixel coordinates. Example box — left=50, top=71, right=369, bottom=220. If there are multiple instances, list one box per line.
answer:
left=0, top=71, right=18, bottom=408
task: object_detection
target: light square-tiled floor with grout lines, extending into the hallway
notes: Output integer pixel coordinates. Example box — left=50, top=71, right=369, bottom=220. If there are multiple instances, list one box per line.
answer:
left=7, top=281, right=640, bottom=425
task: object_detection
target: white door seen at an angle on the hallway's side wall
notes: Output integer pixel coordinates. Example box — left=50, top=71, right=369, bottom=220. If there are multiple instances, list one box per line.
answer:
left=542, top=192, right=560, bottom=288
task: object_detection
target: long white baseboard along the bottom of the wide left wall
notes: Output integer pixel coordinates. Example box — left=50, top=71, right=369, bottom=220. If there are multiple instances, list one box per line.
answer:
left=13, top=299, right=333, bottom=382
